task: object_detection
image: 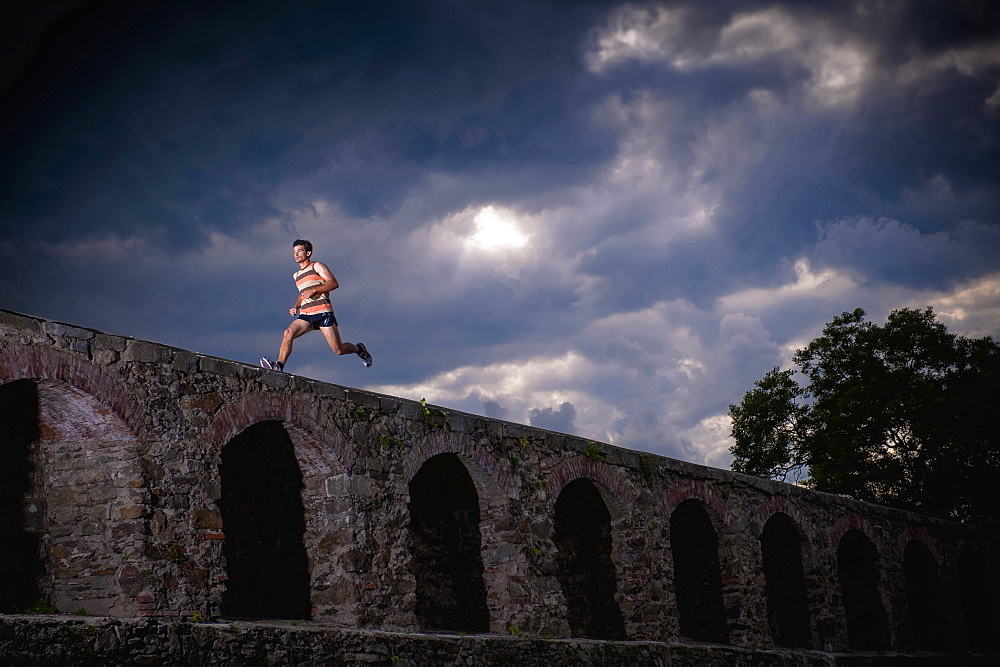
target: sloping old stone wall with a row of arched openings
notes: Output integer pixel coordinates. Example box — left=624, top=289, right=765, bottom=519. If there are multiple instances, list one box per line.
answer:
left=0, top=311, right=1000, bottom=652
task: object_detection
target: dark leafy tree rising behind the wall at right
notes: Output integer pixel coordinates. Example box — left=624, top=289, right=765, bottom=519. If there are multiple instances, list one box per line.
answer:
left=729, top=308, right=1000, bottom=526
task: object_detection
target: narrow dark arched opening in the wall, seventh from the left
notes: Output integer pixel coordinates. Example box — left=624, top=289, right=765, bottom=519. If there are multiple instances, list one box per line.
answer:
left=837, top=530, right=889, bottom=649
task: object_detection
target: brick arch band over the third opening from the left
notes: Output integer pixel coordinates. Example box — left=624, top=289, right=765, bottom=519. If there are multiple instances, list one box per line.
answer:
left=403, top=431, right=518, bottom=504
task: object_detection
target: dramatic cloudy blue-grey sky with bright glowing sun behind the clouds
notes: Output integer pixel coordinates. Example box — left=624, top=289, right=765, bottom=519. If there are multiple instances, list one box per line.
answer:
left=0, top=0, right=1000, bottom=467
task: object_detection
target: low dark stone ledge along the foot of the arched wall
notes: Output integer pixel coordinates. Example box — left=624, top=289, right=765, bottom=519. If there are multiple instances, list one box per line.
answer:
left=0, top=612, right=995, bottom=667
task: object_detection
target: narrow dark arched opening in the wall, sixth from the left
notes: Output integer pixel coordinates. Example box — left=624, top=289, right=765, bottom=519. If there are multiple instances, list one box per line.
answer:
left=760, top=512, right=810, bottom=647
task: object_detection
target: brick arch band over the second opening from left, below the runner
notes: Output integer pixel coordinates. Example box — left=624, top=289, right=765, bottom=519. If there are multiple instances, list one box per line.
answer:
left=200, top=391, right=355, bottom=468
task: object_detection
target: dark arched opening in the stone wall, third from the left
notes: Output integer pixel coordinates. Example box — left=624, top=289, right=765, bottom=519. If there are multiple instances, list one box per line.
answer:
left=409, top=454, right=490, bottom=632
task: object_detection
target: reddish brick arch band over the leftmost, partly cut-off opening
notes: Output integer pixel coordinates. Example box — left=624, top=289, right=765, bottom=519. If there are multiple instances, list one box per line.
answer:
left=0, top=345, right=146, bottom=440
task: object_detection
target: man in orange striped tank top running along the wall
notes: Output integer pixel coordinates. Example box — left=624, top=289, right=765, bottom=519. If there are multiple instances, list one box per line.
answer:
left=260, top=239, right=372, bottom=371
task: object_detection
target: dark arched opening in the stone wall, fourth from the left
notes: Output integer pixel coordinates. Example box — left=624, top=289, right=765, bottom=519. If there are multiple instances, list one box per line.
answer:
left=554, top=479, right=625, bottom=639
